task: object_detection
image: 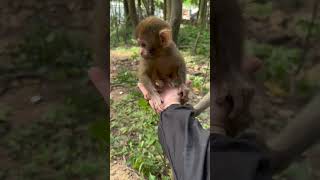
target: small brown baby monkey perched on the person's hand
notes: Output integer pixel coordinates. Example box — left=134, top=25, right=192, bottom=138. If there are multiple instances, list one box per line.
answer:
left=136, top=16, right=188, bottom=111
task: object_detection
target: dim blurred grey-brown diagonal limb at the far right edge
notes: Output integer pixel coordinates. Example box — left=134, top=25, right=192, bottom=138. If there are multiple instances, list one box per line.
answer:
left=268, top=94, right=320, bottom=173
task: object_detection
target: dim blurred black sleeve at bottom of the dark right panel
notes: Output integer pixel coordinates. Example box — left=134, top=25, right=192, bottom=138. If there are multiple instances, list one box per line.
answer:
left=210, top=134, right=272, bottom=180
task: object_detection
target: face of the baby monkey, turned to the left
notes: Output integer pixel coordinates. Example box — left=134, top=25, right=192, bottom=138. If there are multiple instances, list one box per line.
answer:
left=138, top=38, right=159, bottom=59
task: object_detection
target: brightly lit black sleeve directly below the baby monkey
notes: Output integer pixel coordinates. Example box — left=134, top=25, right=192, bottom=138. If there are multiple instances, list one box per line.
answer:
left=158, top=105, right=209, bottom=180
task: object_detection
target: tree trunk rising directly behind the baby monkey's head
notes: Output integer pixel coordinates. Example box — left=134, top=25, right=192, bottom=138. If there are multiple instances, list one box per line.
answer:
left=170, top=0, right=182, bottom=44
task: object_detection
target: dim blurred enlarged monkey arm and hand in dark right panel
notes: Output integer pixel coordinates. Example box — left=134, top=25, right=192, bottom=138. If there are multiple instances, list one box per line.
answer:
left=210, top=0, right=254, bottom=136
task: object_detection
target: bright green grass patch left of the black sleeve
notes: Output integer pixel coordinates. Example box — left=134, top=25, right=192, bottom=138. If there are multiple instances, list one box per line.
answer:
left=111, top=91, right=168, bottom=178
